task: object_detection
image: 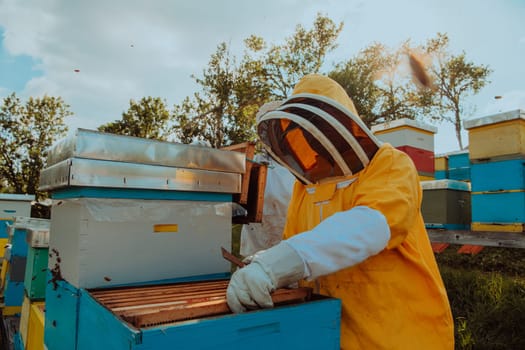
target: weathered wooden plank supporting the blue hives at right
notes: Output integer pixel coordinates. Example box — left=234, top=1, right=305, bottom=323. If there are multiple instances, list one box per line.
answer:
left=427, top=229, right=525, bottom=248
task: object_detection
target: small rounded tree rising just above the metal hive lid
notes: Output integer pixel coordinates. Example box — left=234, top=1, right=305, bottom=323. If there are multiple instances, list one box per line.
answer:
left=98, top=96, right=170, bottom=140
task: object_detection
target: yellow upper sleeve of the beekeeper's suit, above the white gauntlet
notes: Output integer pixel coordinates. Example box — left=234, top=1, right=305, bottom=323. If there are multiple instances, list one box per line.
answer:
left=352, top=144, right=421, bottom=249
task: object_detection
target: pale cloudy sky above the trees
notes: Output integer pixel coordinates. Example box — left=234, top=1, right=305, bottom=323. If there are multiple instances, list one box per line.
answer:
left=0, top=0, right=525, bottom=154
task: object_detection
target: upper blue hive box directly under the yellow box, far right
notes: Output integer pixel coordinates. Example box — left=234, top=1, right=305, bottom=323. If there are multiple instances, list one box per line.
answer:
left=471, top=158, right=525, bottom=192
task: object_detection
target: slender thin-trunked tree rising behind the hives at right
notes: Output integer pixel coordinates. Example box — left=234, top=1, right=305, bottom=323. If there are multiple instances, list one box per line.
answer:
left=420, top=33, right=492, bottom=149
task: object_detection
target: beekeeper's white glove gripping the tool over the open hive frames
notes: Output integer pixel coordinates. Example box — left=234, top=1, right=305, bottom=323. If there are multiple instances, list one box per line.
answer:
left=226, top=241, right=305, bottom=313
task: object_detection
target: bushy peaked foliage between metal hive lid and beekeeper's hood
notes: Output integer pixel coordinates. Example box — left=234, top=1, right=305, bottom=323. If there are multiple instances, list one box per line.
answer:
left=173, top=43, right=260, bottom=148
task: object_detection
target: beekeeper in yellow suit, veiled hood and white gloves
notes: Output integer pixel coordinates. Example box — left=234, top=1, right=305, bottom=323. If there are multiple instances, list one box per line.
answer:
left=227, top=74, right=454, bottom=350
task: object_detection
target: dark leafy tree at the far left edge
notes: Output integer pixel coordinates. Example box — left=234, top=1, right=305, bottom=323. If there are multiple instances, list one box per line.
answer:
left=0, top=93, right=73, bottom=199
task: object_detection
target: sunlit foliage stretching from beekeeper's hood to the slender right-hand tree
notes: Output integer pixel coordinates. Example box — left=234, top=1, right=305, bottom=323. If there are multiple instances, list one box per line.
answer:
left=329, top=33, right=491, bottom=139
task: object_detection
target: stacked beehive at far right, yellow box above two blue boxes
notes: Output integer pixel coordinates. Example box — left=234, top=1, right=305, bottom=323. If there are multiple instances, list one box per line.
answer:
left=464, top=110, right=525, bottom=232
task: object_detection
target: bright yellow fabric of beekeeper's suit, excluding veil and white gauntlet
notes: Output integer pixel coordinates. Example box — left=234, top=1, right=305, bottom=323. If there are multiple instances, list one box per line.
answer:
left=284, top=78, right=454, bottom=350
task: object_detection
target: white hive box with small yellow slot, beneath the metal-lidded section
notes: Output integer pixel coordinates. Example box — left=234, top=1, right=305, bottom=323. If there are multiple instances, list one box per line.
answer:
left=49, top=198, right=231, bottom=288
